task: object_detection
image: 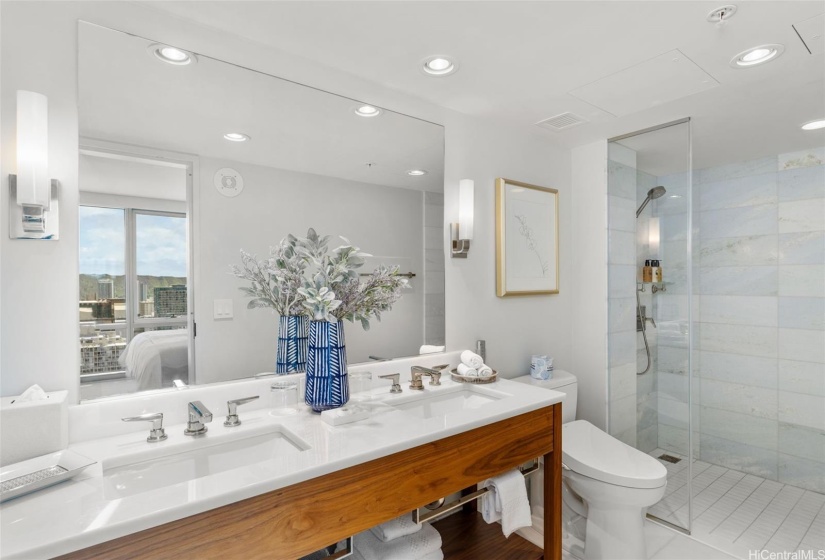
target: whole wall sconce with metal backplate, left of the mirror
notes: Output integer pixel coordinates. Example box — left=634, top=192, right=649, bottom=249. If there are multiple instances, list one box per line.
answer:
left=9, top=90, right=58, bottom=240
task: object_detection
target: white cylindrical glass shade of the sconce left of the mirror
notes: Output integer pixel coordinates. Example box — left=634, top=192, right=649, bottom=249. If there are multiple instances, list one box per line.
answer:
left=17, top=90, right=51, bottom=209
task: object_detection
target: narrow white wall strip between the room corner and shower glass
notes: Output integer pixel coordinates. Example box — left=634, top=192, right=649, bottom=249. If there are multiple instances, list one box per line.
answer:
left=570, top=141, right=607, bottom=428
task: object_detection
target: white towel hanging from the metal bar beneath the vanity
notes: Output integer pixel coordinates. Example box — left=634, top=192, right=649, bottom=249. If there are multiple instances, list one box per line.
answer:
left=481, top=469, right=533, bottom=537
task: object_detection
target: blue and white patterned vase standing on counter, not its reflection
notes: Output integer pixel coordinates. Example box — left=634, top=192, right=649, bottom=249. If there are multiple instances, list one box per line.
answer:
left=304, top=321, right=349, bottom=412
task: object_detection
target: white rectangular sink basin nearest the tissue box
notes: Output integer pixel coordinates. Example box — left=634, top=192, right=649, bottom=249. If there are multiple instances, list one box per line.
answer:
left=103, top=426, right=309, bottom=500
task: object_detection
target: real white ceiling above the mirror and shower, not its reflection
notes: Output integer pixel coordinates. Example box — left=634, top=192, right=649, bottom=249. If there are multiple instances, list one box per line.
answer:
left=145, top=0, right=825, bottom=173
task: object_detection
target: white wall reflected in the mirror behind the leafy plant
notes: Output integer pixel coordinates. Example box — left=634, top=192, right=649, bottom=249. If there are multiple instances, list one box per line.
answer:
left=195, top=158, right=424, bottom=383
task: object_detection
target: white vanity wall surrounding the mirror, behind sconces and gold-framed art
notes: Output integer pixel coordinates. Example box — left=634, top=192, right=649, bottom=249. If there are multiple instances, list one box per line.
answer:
left=0, top=2, right=572, bottom=402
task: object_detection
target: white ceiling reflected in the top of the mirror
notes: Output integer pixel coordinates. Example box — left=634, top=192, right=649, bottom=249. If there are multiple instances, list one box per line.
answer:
left=78, top=22, right=444, bottom=192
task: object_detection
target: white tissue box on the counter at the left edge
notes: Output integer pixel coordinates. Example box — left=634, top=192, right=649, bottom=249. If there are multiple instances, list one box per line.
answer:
left=0, top=391, right=69, bottom=466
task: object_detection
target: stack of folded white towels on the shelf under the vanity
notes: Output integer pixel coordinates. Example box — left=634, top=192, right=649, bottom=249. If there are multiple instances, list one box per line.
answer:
left=352, top=514, right=444, bottom=560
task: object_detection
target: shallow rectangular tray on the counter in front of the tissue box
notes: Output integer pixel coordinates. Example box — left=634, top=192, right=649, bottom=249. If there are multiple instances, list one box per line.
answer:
left=0, top=449, right=97, bottom=503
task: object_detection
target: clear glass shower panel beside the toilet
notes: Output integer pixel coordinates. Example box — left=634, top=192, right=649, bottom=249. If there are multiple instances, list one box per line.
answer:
left=608, top=120, right=693, bottom=531
